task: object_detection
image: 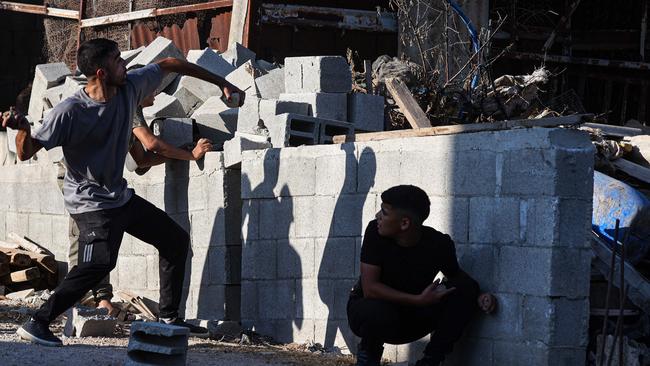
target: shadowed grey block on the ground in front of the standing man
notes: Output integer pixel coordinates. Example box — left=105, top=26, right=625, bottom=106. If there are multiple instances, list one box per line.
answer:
left=125, top=322, right=190, bottom=366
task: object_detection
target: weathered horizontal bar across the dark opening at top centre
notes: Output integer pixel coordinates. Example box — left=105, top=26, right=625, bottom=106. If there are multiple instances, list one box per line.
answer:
left=260, top=3, right=397, bottom=33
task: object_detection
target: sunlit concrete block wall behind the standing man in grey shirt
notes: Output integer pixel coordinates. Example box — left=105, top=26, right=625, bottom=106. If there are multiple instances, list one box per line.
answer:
left=0, top=152, right=241, bottom=319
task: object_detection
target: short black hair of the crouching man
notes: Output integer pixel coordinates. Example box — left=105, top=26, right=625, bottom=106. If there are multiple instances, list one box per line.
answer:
left=381, top=185, right=431, bottom=225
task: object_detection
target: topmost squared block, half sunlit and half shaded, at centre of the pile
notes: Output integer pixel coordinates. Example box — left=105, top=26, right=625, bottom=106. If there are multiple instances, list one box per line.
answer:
left=284, top=56, right=352, bottom=93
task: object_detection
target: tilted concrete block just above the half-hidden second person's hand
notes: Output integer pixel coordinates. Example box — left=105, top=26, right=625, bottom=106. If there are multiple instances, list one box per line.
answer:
left=192, top=97, right=238, bottom=149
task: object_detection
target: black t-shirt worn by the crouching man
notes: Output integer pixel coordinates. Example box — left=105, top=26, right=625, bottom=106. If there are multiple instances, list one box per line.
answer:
left=353, top=220, right=459, bottom=296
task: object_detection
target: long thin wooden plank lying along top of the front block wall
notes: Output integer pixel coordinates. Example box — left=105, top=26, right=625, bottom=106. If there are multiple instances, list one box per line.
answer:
left=333, top=114, right=593, bottom=144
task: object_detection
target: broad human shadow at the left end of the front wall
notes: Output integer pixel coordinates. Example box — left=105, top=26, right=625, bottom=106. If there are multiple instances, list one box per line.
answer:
left=241, top=149, right=303, bottom=342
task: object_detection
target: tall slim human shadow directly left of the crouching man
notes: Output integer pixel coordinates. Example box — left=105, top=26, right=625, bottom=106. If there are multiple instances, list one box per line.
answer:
left=318, top=144, right=377, bottom=350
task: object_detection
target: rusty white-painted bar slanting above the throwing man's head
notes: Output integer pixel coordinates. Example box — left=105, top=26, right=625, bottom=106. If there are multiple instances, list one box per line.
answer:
left=81, top=0, right=232, bottom=28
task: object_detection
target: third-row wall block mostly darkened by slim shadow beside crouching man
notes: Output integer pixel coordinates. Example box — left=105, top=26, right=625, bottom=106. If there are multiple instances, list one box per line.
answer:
left=314, top=238, right=356, bottom=278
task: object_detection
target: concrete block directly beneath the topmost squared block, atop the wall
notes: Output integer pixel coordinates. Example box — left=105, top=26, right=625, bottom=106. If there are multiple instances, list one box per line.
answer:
left=280, top=89, right=348, bottom=121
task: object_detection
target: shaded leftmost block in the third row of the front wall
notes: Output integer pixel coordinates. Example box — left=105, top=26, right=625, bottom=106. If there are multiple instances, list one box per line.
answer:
left=241, top=240, right=277, bottom=282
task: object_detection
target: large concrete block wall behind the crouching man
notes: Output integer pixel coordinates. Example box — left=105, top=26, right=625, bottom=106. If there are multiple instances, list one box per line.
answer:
left=241, top=128, right=593, bottom=365
